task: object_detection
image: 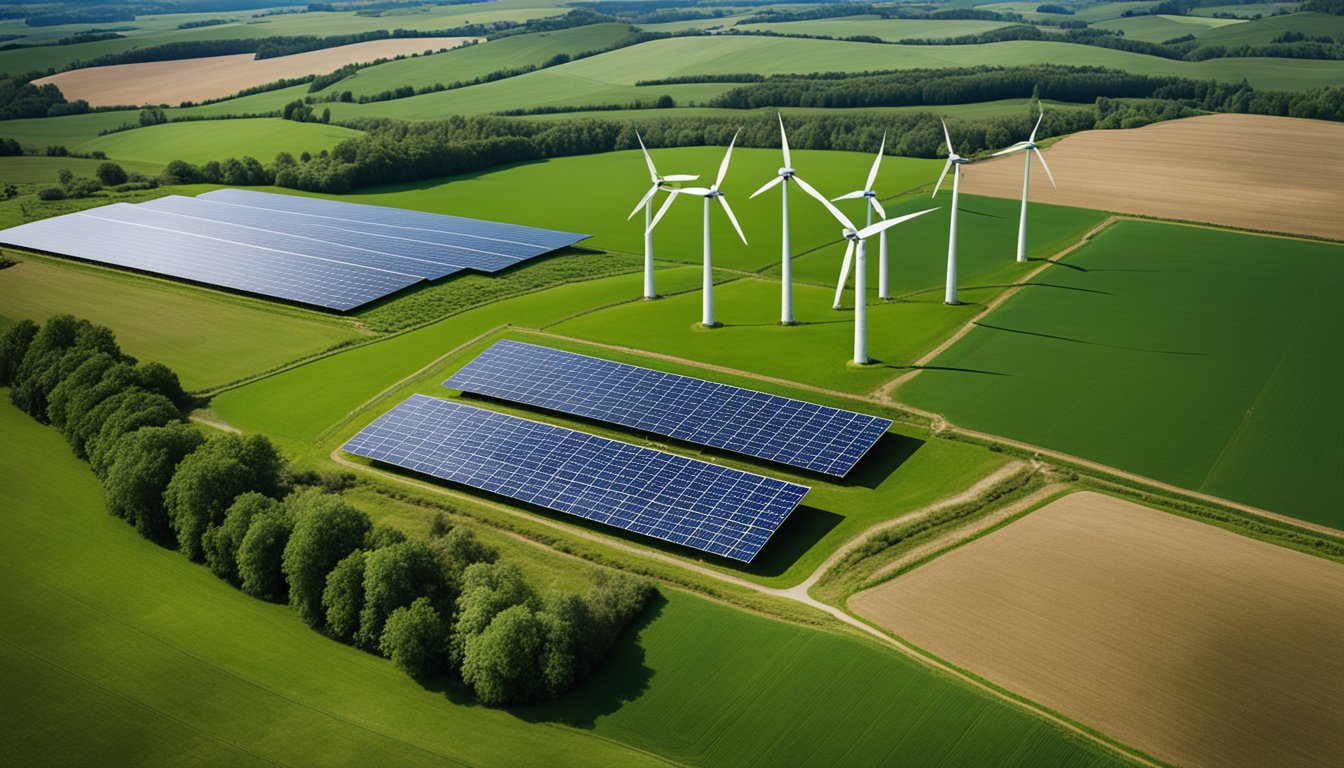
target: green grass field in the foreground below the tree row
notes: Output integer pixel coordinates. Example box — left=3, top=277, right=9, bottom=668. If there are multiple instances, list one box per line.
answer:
left=0, top=397, right=1120, bottom=767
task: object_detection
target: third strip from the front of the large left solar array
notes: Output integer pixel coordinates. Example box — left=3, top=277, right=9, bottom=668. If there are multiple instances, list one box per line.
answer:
left=136, top=195, right=517, bottom=272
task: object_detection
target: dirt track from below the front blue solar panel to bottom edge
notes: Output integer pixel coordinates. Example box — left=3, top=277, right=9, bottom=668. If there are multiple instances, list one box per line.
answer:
left=331, top=448, right=1163, bottom=768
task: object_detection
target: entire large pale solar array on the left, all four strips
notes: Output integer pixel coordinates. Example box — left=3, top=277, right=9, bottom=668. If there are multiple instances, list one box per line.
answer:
left=0, top=190, right=589, bottom=311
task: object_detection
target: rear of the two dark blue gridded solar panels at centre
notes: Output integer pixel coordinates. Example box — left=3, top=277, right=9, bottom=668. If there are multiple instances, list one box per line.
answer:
left=444, top=340, right=891, bottom=477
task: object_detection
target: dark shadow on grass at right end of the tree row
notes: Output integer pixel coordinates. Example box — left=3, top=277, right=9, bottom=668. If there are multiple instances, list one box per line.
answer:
left=508, top=593, right=668, bottom=730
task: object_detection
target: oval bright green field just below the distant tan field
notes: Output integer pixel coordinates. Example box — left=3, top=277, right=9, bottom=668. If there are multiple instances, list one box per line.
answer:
left=78, top=117, right=360, bottom=163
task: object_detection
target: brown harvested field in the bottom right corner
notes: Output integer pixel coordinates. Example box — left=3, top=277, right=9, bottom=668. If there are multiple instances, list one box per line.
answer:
left=849, top=492, right=1344, bottom=767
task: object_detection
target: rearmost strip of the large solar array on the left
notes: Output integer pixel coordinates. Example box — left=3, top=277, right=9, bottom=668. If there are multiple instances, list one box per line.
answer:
left=200, top=190, right=589, bottom=260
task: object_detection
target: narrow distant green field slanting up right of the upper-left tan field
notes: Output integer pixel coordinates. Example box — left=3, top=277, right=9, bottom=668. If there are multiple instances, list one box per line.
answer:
left=319, top=24, right=642, bottom=97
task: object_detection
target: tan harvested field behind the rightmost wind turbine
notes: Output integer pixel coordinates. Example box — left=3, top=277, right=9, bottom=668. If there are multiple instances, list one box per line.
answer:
left=962, top=114, right=1344, bottom=239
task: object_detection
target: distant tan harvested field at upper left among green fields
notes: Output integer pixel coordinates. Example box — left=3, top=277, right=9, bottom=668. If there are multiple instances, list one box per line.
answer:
left=34, top=38, right=474, bottom=106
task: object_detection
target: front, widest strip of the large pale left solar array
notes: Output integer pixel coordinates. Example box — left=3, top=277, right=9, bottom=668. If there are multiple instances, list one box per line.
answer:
left=0, top=213, right=421, bottom=311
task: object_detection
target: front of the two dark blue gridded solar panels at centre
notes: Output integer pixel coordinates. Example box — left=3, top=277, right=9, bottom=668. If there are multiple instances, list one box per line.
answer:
left=344, top=394, right=808, bottom=562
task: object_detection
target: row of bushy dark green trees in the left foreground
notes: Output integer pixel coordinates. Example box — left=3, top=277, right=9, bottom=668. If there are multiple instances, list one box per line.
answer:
left=0, top=315, right=653, bottom=706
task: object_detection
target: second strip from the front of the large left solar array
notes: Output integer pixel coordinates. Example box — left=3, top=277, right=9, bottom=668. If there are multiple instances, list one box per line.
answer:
left=83, top=203, right=461, bottom=280
